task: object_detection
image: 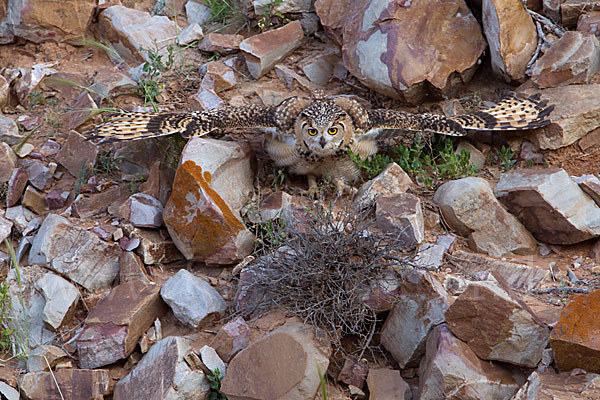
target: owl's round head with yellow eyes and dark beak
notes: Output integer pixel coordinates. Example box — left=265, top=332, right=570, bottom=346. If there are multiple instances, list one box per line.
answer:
left=295, top=101, right=353, bottom=156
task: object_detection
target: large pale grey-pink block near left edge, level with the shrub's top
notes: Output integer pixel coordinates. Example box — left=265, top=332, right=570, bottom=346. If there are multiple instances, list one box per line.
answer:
left=29, top=214, right=121, bottom=291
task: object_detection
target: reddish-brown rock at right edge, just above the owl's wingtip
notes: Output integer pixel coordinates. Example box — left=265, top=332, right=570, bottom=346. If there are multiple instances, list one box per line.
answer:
left=531, top=31, right=600, bottom=88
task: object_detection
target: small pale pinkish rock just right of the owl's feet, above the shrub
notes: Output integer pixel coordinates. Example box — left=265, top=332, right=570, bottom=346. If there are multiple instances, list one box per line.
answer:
left=352, top=163, right=414, bottom=210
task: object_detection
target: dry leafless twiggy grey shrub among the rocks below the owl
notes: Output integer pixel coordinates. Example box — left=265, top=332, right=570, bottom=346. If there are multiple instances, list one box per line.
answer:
left=237, top=202, right=418, bottom=356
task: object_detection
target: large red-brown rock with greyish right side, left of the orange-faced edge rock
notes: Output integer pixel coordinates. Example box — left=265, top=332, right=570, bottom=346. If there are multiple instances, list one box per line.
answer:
left=445, top=282, right=549, bottom=368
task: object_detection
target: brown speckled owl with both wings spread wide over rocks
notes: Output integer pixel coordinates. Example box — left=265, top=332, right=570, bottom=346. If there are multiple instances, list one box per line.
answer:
left=88, top=91, right=554, bottom=194
